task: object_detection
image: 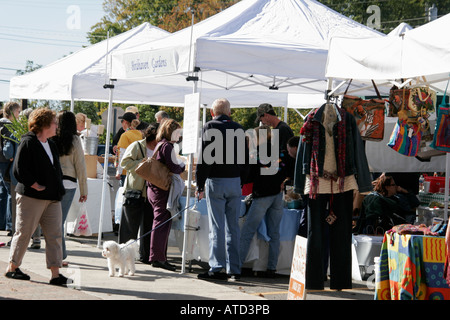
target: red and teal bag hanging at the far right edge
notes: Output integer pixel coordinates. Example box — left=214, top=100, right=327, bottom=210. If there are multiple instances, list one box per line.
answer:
left=430, top=82, right=450, bottom=152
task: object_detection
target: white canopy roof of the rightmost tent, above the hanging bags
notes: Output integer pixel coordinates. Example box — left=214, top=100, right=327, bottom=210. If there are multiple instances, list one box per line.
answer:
left=326, top=14, right=450, bottom=92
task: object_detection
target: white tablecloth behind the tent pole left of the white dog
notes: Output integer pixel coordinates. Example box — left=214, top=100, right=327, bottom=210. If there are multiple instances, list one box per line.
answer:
left=66, top=178, right=113, bottom=234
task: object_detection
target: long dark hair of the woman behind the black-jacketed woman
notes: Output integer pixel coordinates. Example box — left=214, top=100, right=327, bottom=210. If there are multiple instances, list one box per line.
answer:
left=53, top=110, right=77, bottom=156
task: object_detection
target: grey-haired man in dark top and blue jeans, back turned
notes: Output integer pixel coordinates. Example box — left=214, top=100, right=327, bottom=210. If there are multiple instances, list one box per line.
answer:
left=196, top=99, right=248, bottom=280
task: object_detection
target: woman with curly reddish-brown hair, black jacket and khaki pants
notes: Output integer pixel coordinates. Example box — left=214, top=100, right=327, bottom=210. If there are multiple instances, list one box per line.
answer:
left=5, top=108, right=67, bottom=285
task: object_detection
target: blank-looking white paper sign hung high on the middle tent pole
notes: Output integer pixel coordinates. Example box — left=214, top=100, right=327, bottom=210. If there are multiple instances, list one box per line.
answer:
left=181, top=92, right=200, bottom=155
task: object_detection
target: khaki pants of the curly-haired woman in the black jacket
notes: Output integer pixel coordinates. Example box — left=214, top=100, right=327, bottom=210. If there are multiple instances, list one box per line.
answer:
left=9, top=194, right=62, bottom=268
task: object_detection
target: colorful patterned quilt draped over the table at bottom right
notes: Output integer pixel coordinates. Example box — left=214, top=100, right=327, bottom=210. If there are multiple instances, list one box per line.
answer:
left=375, top=232, right=450, bottom=300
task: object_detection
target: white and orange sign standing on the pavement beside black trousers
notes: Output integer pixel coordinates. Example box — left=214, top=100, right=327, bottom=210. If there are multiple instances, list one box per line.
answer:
left=287, top=236, right=308, bottom=300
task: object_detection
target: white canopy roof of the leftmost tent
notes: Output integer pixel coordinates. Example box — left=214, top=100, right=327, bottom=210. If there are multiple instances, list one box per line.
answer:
left=9, top=22, right=170, bottom=107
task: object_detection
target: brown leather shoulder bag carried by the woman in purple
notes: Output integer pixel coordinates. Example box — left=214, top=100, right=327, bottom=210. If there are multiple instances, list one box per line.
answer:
left=135, top=144, right=172, bottom=191
